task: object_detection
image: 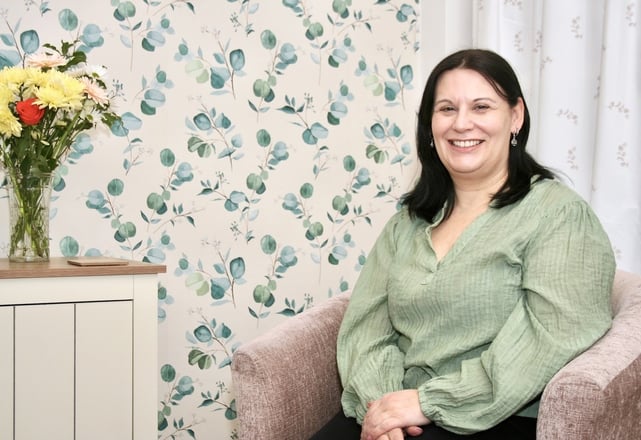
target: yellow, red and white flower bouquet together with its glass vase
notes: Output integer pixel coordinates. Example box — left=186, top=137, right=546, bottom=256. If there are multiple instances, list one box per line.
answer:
left=0, top=42, right=120, bottom=261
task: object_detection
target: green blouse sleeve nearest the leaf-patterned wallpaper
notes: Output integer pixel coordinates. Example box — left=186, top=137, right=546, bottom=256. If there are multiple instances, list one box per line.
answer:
left=337, top=214, right=404, bottom=423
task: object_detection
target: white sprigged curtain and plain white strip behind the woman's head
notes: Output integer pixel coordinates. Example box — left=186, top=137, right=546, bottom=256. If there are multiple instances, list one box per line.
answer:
left=422, top=0, right=641, bottom=273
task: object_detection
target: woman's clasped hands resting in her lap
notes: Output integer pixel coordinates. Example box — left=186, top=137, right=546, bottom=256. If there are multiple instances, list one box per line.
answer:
left=361, top=390, right=430, bottom=440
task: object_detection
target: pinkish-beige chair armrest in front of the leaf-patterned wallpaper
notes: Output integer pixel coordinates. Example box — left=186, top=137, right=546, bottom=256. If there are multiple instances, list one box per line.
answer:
left=231, top=294, right=349, bottom=440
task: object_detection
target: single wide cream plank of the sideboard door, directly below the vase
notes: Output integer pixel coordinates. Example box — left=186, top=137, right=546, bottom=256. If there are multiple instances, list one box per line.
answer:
left=14, top=304, right=75, bottom=440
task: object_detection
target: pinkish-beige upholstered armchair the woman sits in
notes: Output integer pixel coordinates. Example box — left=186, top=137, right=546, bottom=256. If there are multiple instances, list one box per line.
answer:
left=232, top=271, right=641, bottom=440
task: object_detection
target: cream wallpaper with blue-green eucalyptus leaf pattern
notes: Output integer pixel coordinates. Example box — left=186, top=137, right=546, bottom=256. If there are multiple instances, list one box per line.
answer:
left=0, top=0, right=422, bottom=439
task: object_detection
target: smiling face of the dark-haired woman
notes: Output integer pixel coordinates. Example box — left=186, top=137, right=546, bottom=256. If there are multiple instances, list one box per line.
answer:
left=432, top=68, right=524, bottom=184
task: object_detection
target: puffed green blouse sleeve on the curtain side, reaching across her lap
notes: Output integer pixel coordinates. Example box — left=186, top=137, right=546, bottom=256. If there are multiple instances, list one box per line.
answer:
left=419, top=201, right=615, bottom=434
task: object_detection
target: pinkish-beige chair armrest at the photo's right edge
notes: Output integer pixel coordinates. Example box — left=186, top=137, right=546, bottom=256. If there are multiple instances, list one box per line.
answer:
left=537, top=271, right=641, bottom=440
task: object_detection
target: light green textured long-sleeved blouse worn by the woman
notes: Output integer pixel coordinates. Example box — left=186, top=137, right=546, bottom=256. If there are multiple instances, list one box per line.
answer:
left=337, top=180, right=615, bottom=434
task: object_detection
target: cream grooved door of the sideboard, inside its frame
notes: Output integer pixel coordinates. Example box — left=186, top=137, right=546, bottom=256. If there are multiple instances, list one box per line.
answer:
left=12, top=301, right=133, bottom=440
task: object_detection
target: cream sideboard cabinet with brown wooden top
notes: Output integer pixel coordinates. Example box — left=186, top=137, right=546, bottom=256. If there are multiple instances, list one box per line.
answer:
left=0, top=258, right=165, bottom=440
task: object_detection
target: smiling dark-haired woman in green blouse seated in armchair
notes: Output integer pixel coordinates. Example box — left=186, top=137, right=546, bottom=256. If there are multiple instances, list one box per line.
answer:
left=314, top=49, right=615, bottom=440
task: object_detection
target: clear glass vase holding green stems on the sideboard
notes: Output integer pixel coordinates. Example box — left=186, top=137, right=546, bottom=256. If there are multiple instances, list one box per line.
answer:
left=7, top=173, right=52, bottom=263
